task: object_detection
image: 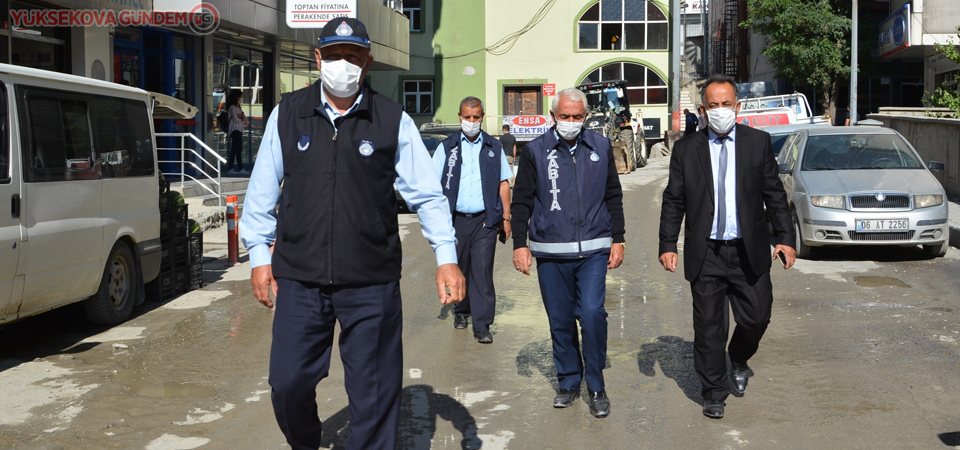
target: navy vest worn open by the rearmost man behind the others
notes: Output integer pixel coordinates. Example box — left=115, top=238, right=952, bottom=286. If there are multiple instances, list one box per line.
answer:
left=440, top=130, right=503, bottom=228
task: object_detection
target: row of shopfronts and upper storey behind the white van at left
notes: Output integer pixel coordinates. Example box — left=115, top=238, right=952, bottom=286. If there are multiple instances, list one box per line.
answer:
left=0, top=0, right=409, bottom=166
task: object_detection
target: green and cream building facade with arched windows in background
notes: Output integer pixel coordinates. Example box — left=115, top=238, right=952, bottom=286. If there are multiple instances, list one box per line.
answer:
left=372, top=0, right=670, bottom=145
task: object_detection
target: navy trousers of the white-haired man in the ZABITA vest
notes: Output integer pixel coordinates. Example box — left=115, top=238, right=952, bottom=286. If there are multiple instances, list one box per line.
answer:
left=537, top=253, right=609, bottom=391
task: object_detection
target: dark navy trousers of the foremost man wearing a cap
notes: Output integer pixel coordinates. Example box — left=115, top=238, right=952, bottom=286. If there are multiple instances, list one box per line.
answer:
left=270, top=279, right=403, bottom=450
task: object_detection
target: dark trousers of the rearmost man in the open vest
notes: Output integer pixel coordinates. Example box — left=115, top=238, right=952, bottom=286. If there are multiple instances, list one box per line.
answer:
left=453, top=212, right=499, bottom=331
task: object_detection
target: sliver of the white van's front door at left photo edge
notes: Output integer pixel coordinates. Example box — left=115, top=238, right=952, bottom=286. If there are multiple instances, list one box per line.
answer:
left=0, top=79, right=23, bottom=323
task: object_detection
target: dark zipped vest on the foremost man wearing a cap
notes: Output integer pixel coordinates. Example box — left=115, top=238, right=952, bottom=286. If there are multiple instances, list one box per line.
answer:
left=272, top=81, right=403, bottom=285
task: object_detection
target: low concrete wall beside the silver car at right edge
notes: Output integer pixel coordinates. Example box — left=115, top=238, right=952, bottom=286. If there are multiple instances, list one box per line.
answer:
left=867, top=108, right=960, bottom=198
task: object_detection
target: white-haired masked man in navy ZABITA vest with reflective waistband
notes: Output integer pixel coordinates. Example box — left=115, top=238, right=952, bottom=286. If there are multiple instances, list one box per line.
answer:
left=512, top=88, right=625, bottom=418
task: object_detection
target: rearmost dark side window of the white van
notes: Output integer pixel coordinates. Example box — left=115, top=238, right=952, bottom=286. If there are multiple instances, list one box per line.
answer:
left=93, top=95, right=155, bottom=178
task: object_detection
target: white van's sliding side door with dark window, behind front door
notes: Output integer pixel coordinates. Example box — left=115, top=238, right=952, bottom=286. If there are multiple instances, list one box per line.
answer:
left=16, top=84, right=106, bottom=315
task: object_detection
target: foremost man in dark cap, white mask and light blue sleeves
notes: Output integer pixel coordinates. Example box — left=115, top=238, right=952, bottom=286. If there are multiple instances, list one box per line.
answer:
left=240, top=18, right=464, bottom=450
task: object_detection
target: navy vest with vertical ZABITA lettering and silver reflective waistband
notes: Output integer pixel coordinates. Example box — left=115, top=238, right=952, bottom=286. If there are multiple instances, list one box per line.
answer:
left=526, top=129, right=613, bottom=259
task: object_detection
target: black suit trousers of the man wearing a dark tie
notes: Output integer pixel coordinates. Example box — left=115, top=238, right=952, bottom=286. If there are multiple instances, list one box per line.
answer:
left=690, top=242, right=773, bottom=401
